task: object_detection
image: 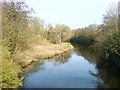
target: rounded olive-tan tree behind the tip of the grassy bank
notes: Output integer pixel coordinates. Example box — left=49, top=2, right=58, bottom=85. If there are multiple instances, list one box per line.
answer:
left=47, top=25, right=71, bottom=43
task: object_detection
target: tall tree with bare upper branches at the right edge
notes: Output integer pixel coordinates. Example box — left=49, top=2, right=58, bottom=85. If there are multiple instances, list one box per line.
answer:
left=104, top=5, right=120, bottom=56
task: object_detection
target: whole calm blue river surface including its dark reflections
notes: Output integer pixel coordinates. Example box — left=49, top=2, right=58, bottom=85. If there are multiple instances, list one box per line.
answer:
left=22, top=47, right=120, bottom=88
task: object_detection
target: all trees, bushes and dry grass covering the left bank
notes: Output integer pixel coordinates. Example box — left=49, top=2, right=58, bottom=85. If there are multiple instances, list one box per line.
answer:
left=0, top=2, right=73, bottom=88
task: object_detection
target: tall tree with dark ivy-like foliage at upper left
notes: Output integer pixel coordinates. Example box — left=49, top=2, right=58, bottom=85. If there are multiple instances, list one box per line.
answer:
left=2, top=2, right=31, bottom=55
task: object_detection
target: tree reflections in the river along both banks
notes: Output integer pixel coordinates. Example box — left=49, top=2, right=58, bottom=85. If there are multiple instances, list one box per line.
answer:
left=25, top=46, right=120, bottom=89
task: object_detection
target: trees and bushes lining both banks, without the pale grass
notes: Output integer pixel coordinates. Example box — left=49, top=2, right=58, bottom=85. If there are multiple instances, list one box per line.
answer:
left=0, top=1, right=120, bottom=88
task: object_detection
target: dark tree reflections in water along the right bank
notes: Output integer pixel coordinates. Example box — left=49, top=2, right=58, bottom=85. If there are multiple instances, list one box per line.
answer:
left=75, top=46, right=120, bottom=89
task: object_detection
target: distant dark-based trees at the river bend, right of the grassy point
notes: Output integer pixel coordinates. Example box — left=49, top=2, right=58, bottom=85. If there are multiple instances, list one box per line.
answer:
left=71, top=27, right=97, bottom=45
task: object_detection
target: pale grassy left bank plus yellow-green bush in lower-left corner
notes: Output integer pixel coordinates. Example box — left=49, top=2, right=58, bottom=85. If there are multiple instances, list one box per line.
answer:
left=2, top=43, right=73, bottom=88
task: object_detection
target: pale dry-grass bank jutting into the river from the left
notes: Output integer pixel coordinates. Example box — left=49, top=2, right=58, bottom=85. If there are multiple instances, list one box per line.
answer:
left=15, top=43, right=74, bottom=68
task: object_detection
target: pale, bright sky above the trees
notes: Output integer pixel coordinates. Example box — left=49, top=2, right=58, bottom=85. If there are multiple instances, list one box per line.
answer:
left=26, top=0, right=119, bottom=29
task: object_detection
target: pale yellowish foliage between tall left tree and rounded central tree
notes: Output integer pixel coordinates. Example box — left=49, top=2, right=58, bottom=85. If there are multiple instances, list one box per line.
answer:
left=27, top=17, right=49, bottom=44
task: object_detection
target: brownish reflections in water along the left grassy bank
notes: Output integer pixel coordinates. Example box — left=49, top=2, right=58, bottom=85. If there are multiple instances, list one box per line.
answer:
left=23, top=51, right=72, bottom=77
